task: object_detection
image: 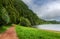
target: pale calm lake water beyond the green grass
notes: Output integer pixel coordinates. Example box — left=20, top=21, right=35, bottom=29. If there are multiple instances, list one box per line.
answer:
left=36, top=24, right=60, bottom=31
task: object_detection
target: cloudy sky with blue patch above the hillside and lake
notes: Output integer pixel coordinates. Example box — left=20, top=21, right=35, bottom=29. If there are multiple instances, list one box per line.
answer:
left=22, top=0, right=60, bottom=21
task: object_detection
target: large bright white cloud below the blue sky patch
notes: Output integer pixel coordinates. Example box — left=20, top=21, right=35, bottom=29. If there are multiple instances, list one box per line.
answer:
left=36, top=2, right=60, bottom=20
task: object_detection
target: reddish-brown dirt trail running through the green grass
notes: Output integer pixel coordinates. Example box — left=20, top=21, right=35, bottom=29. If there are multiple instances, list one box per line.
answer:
left=0, top=26, right=18, bottom=39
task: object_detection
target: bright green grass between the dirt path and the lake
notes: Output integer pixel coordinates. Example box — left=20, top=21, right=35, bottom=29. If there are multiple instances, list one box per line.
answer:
left=16, top=25, right=60, bottom=39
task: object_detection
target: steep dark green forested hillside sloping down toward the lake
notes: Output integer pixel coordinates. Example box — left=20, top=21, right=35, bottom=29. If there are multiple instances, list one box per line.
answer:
left=0, top=0, right=59, bottom=26
